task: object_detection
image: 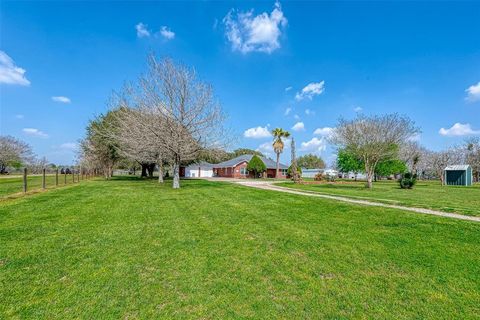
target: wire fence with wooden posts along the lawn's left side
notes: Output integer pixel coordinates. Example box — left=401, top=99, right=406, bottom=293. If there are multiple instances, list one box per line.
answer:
left=0, top=168, right=98, bottom=199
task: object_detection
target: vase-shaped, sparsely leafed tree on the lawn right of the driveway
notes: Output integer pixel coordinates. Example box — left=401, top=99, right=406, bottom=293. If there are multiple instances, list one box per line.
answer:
left=330, top=113, right=419, bottom=188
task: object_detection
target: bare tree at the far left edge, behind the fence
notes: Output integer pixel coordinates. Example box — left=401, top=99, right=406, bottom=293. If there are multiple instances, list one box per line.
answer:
left=0, top=136, right=34, bottom=174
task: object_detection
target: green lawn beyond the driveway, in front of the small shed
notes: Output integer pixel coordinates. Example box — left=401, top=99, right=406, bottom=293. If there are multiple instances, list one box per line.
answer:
left=279, top=181, right=480, bottom=216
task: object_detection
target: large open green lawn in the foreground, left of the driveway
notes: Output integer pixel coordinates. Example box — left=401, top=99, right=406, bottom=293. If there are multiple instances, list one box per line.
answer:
left=0, top=178, right=480, bottom=319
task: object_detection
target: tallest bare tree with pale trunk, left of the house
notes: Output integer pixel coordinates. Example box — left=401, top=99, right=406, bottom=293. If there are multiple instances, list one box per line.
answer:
left=109, top=54, right=224, bottom=188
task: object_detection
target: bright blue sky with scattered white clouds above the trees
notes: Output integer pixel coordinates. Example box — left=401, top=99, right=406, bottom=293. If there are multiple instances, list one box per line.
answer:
left=0, top=1, right=480, bottom=163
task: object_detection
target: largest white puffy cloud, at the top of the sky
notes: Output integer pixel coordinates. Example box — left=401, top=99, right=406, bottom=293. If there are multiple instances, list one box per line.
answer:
left=223, top=2, right=287, bottom=53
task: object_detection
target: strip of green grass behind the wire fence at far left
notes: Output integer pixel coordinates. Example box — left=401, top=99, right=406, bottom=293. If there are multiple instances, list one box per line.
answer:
left=0, top=174, right=77, bottom=199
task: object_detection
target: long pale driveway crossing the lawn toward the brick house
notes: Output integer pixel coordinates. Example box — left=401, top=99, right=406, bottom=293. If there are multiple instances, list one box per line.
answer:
left=233, top=179, right=480, bottom=222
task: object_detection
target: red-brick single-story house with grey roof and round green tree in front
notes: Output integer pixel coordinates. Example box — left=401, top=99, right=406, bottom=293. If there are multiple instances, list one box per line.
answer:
left=213, top=154, right=288, bottom=179
